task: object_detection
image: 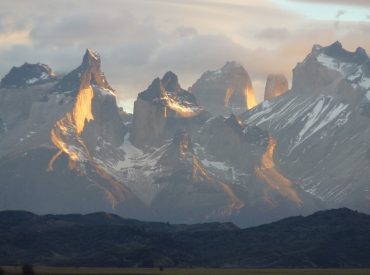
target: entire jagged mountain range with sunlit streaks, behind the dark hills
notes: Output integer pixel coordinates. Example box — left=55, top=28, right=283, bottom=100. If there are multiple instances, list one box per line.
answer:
left=0, top=42, right=370, bottom=227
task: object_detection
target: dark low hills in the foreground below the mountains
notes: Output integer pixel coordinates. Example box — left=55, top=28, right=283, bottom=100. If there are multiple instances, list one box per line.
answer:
left=0, top=208, right=370, bottom=267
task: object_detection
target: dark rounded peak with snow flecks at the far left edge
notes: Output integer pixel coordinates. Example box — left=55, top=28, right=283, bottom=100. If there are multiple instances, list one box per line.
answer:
left=0, top=62, right=56, bottom=88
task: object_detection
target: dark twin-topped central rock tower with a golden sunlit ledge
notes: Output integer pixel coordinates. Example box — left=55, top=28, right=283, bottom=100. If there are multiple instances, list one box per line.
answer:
left=131, top=72, right=209, bottom=146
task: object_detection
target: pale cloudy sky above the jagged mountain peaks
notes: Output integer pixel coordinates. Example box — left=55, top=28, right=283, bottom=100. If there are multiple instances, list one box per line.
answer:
left=0, top=0, right=370, bottom=111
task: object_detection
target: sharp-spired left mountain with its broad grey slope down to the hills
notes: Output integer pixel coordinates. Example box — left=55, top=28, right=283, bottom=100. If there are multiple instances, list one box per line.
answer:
left=0, top=50, right=148, bottom=218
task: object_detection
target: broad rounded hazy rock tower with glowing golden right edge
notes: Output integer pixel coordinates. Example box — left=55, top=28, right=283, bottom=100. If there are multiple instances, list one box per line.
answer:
left=191, top=62, right=257, bottom=116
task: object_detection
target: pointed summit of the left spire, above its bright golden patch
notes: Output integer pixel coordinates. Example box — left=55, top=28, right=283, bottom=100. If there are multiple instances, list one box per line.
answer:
left=56, top=49, right=114, bottom=94
